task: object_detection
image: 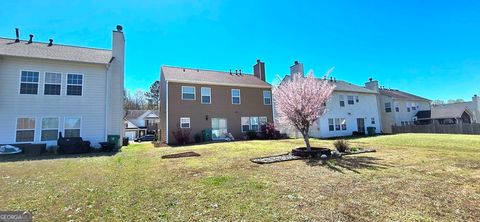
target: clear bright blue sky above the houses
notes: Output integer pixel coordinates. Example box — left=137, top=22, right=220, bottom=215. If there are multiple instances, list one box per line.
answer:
left=0, top=0, right=480, bottom=100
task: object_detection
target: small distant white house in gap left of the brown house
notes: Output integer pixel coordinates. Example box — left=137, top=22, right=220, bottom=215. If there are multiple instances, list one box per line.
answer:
left=125, top=110, right=159, bottom=140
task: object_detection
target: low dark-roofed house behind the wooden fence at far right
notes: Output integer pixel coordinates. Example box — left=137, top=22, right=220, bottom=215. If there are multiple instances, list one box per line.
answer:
left=416, top=95, right=480, bottom=124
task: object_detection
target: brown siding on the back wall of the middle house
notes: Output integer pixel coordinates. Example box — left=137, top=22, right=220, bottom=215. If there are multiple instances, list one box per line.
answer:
left=168, top=82, right=273, bottom=143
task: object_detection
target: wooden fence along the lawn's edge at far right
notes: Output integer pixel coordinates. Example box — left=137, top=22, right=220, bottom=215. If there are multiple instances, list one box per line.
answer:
left=392, top=123, right=480, bottom=135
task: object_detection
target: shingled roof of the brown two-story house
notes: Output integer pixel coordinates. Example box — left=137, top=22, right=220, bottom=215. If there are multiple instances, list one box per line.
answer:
left=162, top=66, right=271, bottom=88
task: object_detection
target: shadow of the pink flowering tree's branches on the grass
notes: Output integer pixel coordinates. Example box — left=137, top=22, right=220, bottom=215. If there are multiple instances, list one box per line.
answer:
left=304, top=156, right=393, bottom=174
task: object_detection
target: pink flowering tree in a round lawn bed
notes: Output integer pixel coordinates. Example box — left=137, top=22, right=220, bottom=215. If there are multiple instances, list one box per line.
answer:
left=273, top=71, right=335, bottom=151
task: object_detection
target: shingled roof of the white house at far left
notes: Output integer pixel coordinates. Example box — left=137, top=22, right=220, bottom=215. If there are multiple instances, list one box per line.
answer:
left=0, top=38, right=112, bottom=64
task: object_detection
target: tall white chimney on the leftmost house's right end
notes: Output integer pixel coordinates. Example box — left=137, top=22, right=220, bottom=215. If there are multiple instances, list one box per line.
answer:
left=106, top=25, right=125, bottom=146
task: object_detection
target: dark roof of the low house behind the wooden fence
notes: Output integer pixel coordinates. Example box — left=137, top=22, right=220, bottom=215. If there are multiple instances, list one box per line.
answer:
left=416, top=103, right=472, bottom=119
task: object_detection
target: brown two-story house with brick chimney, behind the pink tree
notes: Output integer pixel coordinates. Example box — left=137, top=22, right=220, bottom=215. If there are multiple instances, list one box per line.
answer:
left=160, top=60, right=273, bottom=144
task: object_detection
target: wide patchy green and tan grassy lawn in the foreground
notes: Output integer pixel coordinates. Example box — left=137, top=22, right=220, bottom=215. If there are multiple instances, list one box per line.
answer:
left=0, top=134, right=480, bottom=221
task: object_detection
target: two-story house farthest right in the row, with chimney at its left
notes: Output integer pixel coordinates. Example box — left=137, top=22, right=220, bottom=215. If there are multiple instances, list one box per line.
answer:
left=365, top=79, right=431, bottom=133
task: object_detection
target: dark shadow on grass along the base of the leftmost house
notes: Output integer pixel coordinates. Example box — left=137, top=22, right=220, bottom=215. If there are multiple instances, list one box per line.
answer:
left=0, top=150, right=121, bottom=163
